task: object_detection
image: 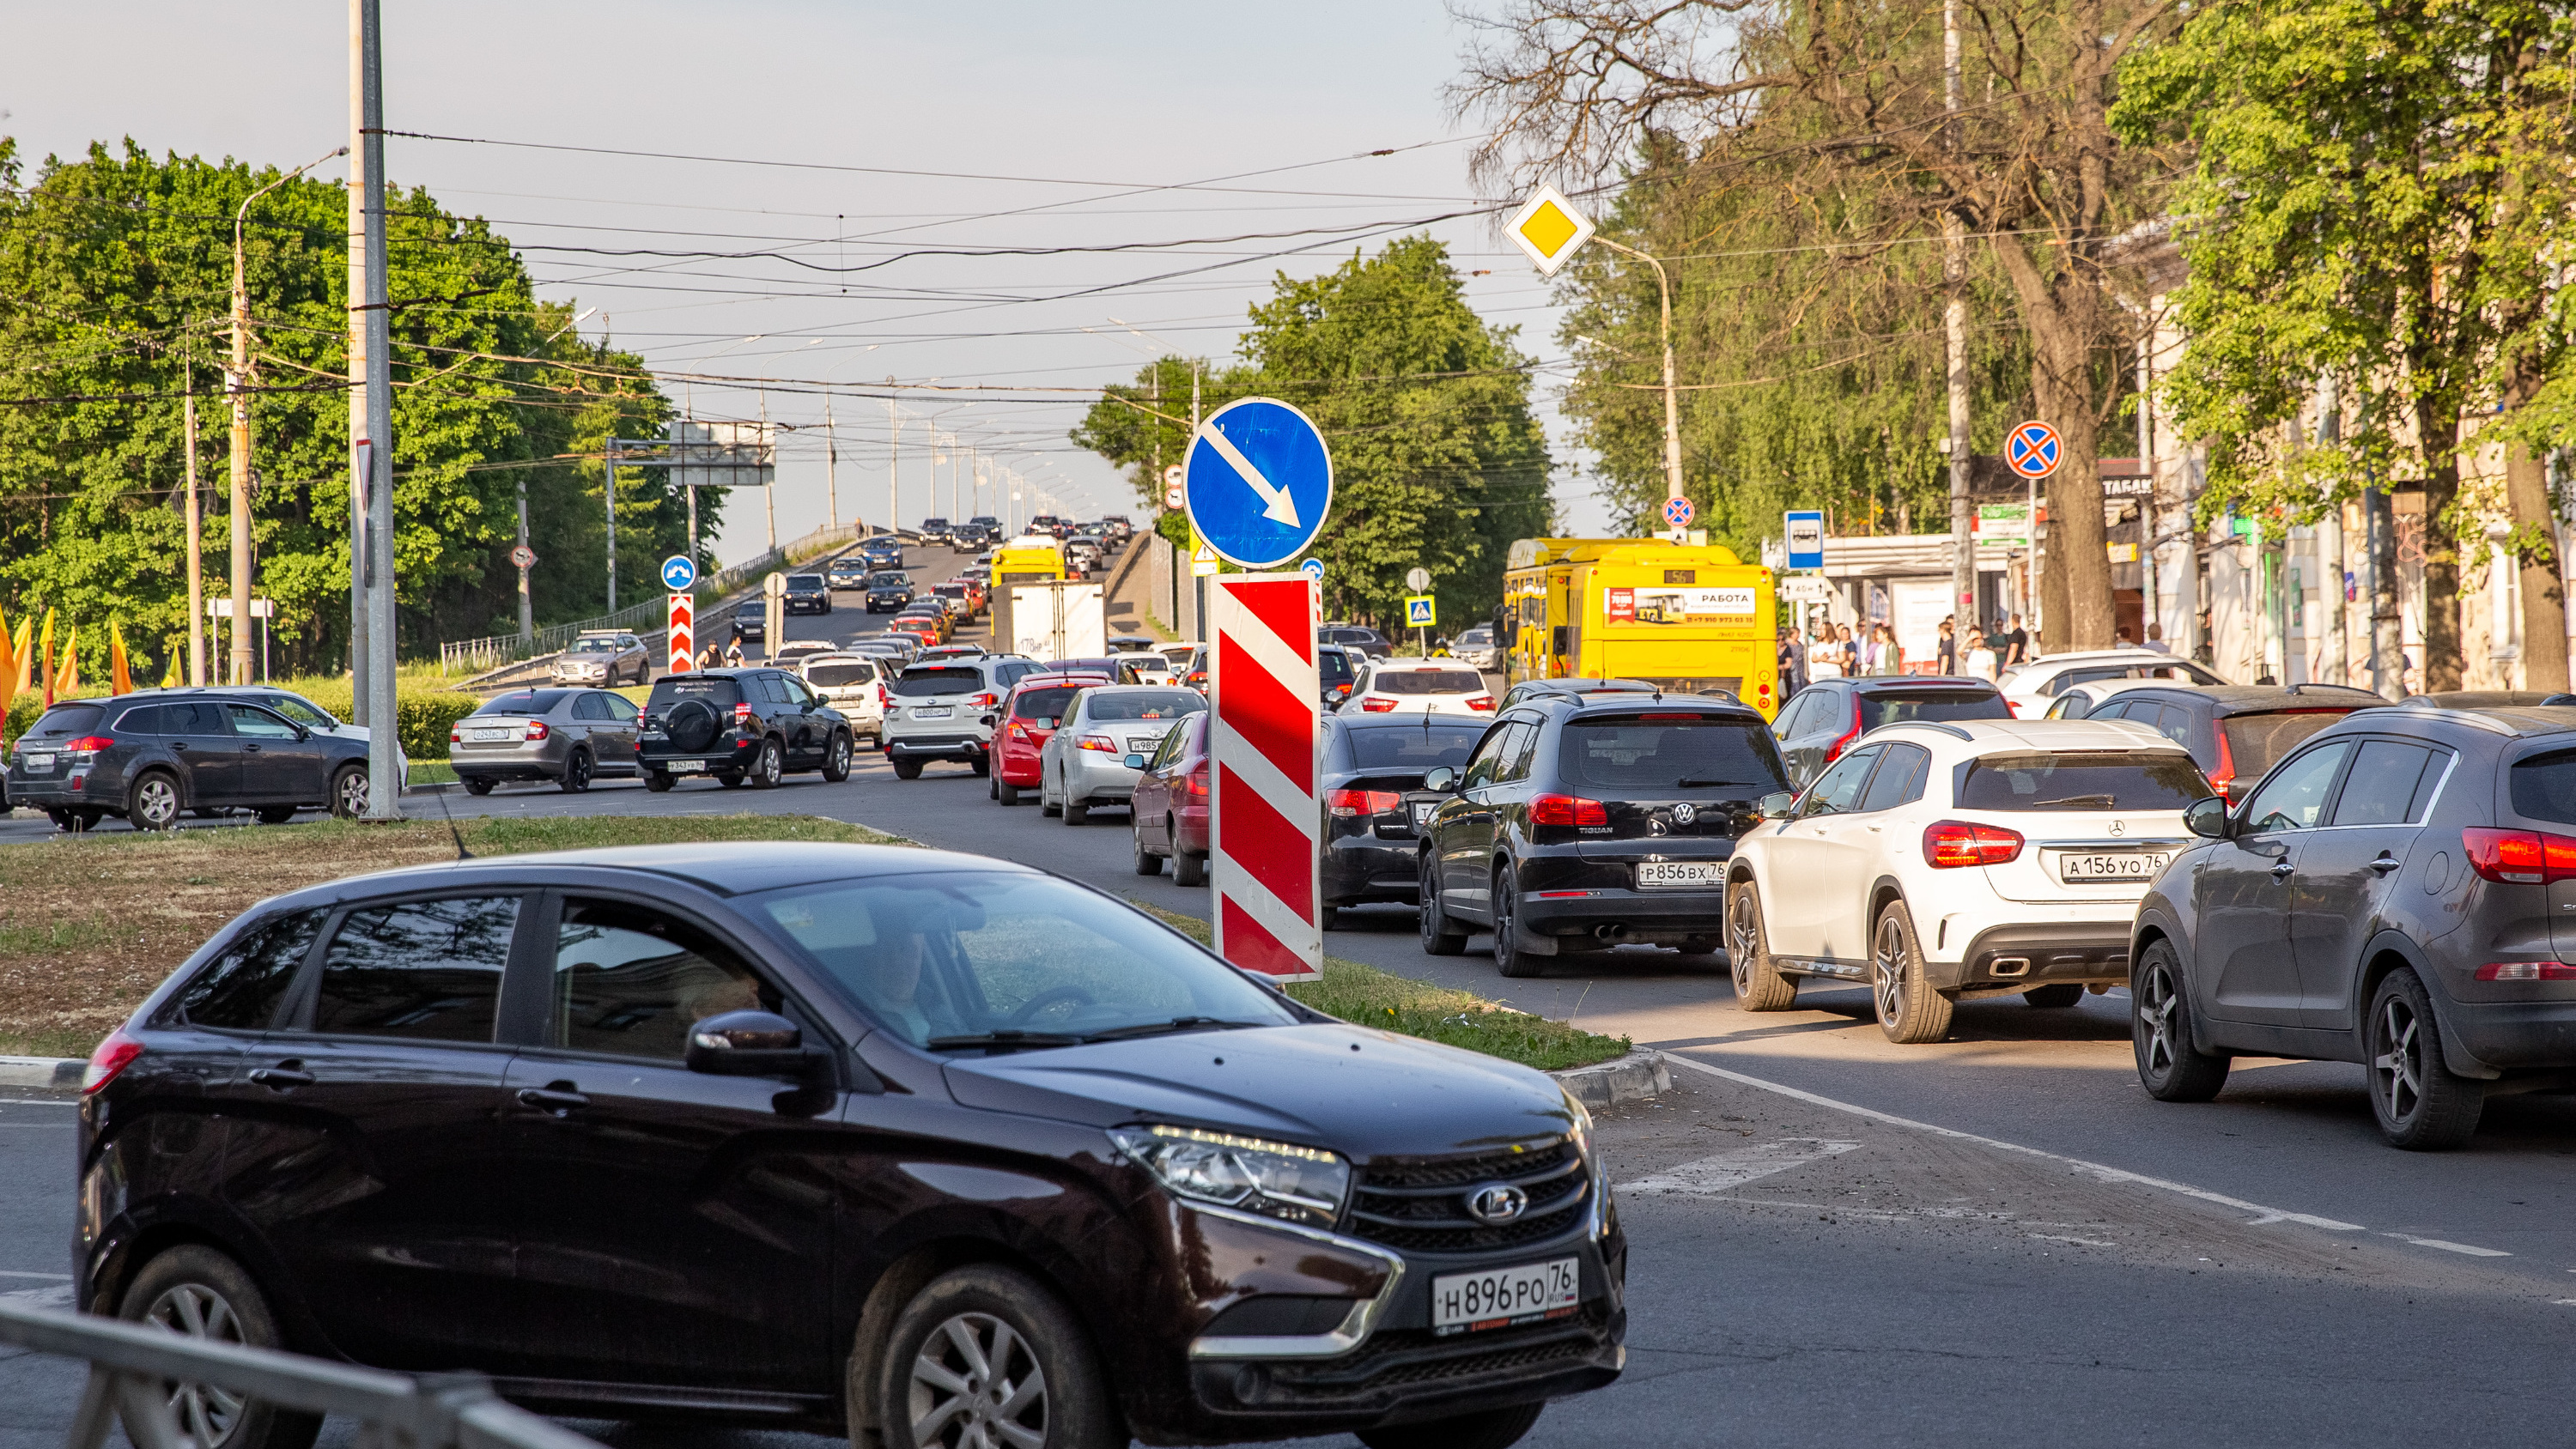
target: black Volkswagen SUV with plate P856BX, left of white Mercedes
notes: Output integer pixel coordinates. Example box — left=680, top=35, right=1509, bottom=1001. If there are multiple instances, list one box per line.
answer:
left=1419, top=693, right=1788, bottom=975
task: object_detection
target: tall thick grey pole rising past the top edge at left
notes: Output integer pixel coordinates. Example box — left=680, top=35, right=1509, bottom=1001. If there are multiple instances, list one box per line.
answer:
left=355, top=0, right=404, bottom=821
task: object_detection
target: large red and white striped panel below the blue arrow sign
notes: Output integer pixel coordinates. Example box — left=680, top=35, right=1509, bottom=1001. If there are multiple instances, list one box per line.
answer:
left=1208, top=574, right=1324, bottom=980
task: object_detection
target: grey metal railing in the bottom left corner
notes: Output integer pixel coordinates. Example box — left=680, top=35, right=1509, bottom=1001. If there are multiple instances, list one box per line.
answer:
left=0, top=1302, right=600, bottom=1449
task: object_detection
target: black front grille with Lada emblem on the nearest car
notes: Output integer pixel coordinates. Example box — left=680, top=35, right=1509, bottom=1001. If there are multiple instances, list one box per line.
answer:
left=1345, top=1137, right=1592, bottom=1253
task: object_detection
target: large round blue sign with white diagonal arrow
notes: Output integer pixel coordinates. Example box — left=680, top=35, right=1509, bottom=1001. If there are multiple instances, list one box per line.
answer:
left=1180, top=397, right=1332, bottom=569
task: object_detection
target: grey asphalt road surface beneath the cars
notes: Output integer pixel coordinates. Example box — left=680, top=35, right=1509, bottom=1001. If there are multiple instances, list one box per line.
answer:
left=0, top=545, right=2576, bottom=1449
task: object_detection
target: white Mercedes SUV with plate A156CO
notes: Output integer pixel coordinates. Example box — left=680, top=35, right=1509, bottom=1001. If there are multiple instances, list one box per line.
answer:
left=1726, top=721, right=2215, bottom=1042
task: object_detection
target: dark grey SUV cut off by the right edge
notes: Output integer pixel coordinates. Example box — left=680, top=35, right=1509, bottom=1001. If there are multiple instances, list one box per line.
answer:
left=2130, top=708, right=2576, bottom=1148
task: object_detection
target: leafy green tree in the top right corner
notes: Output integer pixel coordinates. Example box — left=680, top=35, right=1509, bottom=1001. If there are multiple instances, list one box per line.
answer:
left=2115, top=0, right=2576, bottom=690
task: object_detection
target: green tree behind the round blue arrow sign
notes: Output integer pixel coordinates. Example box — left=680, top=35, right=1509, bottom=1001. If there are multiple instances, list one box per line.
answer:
left=1074, top=237, right=1548, bottom=628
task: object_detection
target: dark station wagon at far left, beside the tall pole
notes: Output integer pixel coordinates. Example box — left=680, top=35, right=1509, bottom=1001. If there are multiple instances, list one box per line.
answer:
left=8, top=690, right=368, bottom=831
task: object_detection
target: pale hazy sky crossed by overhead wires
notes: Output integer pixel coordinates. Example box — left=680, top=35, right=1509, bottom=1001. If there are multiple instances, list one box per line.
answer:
left=0, top=0, right=1605, bottom=576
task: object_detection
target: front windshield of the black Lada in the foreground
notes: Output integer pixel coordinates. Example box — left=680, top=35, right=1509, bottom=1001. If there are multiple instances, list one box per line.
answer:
left=757, top=870, right=1296, bottom=1050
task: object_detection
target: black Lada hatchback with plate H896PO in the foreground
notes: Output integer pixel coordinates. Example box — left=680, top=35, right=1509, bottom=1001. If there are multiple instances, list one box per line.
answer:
left=72, top=844, right=1625, bottom=1449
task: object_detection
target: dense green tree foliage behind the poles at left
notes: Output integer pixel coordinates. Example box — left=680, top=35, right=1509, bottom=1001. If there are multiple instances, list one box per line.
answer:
left=0, top=139, right=716, bottom=670
